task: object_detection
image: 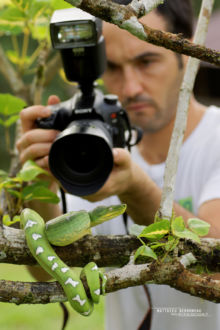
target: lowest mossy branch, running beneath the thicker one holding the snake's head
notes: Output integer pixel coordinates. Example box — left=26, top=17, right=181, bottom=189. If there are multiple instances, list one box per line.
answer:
left=0, top=260, right=220, bottom=304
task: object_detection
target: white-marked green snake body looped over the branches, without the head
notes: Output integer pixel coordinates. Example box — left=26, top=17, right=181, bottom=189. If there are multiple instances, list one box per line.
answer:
left=21, top=208, right=107, bottom=316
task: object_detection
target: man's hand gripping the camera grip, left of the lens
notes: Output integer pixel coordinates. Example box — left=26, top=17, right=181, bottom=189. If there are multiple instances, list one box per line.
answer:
left=16, top=95, right=60, bottom=170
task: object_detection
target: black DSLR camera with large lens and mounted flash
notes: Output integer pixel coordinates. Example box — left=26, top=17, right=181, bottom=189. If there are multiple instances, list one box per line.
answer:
left=37, top=8, right=141, bottom=196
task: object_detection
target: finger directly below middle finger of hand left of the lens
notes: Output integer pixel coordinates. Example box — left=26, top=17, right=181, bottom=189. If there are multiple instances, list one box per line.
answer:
left=20, top=143, right=51, bottom=163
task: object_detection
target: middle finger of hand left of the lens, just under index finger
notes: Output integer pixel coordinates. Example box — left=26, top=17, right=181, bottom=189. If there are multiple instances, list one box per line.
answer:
left=16, top=128, right=59, bottom=152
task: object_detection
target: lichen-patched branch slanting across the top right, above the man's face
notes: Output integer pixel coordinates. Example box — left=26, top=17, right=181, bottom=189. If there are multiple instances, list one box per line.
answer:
left=65, top=0, right=220, bottom=66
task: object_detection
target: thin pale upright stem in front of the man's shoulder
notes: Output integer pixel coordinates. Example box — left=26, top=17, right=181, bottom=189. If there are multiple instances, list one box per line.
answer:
left=159, top=0, right=214, bottom=219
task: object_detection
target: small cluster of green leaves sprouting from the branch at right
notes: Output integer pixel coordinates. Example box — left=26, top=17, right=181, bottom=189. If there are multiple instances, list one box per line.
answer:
left=129, top=216, right=210, bottom=260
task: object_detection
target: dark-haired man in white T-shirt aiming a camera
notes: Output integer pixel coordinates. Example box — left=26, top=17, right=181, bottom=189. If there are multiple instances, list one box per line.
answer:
left=17, top=0, right=220, bottom=330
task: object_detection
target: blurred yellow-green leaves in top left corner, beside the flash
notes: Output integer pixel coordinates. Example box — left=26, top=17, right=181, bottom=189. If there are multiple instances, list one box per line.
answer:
left=0, top=0, right=70, bottom=76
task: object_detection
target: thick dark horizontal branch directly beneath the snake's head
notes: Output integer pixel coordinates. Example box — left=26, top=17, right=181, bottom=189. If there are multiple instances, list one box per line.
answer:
left=0, top=226, right=220, bottom=272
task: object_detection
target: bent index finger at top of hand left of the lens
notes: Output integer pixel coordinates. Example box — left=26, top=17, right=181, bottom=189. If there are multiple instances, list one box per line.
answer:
left=20, top=105, right=51, bottom=133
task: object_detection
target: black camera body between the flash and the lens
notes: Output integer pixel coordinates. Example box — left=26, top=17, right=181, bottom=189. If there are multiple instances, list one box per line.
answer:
left=38, top=89, right=132, bottom=148
